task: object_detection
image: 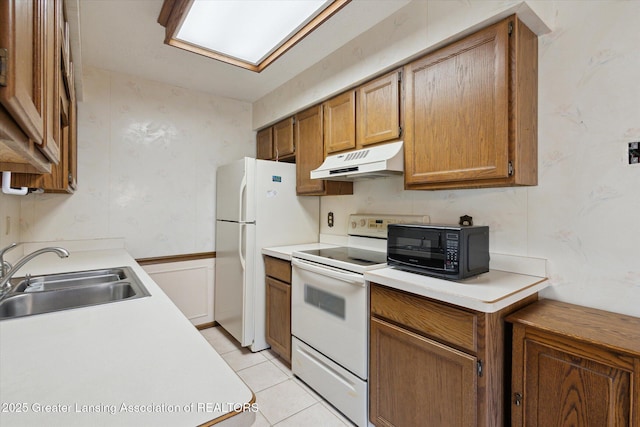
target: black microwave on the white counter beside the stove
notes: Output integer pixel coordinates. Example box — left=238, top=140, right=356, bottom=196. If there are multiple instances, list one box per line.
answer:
left=387, top=224, right=489, bottom=280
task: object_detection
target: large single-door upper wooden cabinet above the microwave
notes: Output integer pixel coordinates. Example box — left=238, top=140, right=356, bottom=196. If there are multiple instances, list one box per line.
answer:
left=404, top=16, right=538, bottom=190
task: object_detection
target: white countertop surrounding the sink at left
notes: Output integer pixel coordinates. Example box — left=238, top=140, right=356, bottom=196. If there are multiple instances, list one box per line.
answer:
left=0, top=249, right=255, bottom=427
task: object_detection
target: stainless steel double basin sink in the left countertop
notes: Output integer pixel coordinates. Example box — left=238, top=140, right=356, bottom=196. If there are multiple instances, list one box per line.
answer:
left=0, top=267, right=151, bottom=320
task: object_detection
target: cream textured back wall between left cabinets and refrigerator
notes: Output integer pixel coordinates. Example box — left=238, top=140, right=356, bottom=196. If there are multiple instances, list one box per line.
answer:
left=20, top=68, right=255, bottom=257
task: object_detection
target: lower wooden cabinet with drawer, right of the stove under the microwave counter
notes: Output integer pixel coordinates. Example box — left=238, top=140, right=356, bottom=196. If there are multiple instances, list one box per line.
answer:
left=369, top=283, right=537, bottom=427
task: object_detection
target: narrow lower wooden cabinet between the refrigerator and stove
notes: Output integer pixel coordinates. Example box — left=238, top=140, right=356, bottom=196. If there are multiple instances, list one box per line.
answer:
left=264, top=256, right=291, bottom=363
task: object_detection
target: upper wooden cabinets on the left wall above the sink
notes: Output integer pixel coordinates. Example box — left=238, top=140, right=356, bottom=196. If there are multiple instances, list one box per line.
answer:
left=0, top=0, right=77, bottom=192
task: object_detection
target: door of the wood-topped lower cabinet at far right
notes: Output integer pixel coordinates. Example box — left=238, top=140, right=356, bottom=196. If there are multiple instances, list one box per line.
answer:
left=514, top=339, right=632, bottom=427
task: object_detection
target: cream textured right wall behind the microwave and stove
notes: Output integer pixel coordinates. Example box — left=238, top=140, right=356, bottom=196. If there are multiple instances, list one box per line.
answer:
left=321, top=1, right=640, bottom=316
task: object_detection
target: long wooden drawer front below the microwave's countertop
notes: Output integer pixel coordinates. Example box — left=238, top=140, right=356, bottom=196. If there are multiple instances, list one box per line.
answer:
left=371, top=283, right=478, bottom=352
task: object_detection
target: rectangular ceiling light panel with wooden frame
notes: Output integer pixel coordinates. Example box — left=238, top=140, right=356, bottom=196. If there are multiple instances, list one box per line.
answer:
left=158, top=0, right=350, bottom=72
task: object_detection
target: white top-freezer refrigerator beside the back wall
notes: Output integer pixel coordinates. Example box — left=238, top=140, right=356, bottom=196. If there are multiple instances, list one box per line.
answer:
left=214, top=157, right=320, bottom=351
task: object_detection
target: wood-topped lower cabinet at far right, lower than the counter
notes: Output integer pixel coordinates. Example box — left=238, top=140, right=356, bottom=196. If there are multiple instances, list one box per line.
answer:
left=507, top=300, right=640, bottom=427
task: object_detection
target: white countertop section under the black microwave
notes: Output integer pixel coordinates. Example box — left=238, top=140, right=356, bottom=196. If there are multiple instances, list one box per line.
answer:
left=364, top=267, right=548, bottom=313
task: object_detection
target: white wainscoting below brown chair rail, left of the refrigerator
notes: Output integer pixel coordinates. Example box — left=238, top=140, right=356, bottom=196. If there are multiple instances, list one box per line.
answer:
left=142, top=258, right=215, bottom=326
